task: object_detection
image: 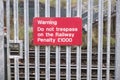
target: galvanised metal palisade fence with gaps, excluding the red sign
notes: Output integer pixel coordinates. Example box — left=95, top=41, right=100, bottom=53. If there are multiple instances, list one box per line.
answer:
left=0, top=0, right=120, bottom=80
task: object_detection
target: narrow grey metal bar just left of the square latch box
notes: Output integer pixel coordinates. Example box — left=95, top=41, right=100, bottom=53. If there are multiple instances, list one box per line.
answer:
left=6, top=0, right=11, bottom=80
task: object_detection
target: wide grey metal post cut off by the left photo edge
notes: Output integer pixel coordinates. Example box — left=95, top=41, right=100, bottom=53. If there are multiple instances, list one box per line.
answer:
left=0, top=0, right=5, bottom=80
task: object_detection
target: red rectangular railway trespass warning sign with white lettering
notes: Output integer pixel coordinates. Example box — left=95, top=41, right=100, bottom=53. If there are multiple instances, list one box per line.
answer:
left=33, top=17, right=82, bottom=45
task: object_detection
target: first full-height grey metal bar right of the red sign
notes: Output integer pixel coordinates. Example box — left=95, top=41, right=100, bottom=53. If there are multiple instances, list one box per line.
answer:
left=87, top=0, right=93, bottom=80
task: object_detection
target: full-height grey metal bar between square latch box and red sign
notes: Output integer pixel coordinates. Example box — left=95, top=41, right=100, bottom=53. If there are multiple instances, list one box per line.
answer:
left=24, top=0, right=29, bottom=80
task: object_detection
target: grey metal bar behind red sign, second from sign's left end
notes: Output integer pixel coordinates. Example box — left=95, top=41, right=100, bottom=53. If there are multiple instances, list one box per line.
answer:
left=45, top=0, right=50, bottom=80
